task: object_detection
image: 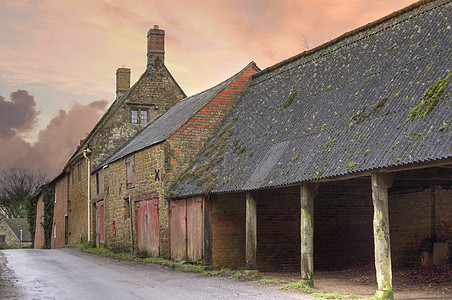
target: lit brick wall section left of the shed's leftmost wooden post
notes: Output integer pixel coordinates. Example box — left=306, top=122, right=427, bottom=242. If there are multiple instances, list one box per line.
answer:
left=212, top=193, right=246, bottom=268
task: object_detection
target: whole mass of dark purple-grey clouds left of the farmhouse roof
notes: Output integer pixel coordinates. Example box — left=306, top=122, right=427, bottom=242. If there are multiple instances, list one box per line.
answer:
left=0, top=91, right=108, bottom=178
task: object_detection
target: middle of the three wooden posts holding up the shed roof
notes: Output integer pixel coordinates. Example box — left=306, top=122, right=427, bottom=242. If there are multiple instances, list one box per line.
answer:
left=300, top=183, right=319, bottom=287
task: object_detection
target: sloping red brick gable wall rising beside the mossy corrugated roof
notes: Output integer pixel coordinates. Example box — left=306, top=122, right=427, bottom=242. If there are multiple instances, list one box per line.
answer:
left=165, top=65, right=257, bottom=187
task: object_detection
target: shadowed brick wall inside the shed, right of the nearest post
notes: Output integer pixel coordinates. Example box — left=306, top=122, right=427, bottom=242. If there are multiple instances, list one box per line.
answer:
left=389, top=187, right=452, bottom=263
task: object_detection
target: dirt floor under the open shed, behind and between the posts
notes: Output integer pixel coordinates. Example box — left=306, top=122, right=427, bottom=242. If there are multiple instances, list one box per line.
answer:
left=260, top=265, right=452, bottom=300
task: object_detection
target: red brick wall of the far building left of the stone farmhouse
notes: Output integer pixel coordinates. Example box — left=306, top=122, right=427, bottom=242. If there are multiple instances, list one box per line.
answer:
left=51, top=173, right=69, bottom=249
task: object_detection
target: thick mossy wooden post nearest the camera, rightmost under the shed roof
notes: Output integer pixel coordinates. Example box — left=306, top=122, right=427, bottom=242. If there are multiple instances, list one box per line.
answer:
left=371, top=173, right=395, bottom=300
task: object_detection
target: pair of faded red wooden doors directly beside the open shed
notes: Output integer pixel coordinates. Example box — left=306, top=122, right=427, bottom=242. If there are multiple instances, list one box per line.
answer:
left=171, top=197, right=203, bottom=262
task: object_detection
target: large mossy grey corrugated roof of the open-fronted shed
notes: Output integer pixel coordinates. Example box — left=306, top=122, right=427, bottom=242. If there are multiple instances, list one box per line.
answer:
left=171, top=0, right=452, bottom=197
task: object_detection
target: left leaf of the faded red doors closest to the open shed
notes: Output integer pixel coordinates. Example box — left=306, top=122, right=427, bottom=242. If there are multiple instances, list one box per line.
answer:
left=170, top=200, right=187, bottom=261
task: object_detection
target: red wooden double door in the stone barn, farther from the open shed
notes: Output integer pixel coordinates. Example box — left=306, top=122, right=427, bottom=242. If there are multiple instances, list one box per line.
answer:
left=135, top=197, right=160, bottom=257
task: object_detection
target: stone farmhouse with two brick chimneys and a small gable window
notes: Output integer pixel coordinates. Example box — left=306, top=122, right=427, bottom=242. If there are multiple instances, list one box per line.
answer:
left=64, top=26, right=186, bottom=244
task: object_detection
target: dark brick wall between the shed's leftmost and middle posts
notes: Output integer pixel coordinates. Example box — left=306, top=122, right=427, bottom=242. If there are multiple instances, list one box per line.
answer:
left=252, top=187, right=300, bottom=270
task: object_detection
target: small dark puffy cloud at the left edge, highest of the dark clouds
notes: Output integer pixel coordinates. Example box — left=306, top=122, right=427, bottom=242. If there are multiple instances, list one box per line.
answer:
left=0, top=90, right=39, bottom=138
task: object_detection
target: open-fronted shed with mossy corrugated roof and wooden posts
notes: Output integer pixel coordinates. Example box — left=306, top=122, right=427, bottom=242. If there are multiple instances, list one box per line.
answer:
left=167, top=0, right=452, bottom=299
